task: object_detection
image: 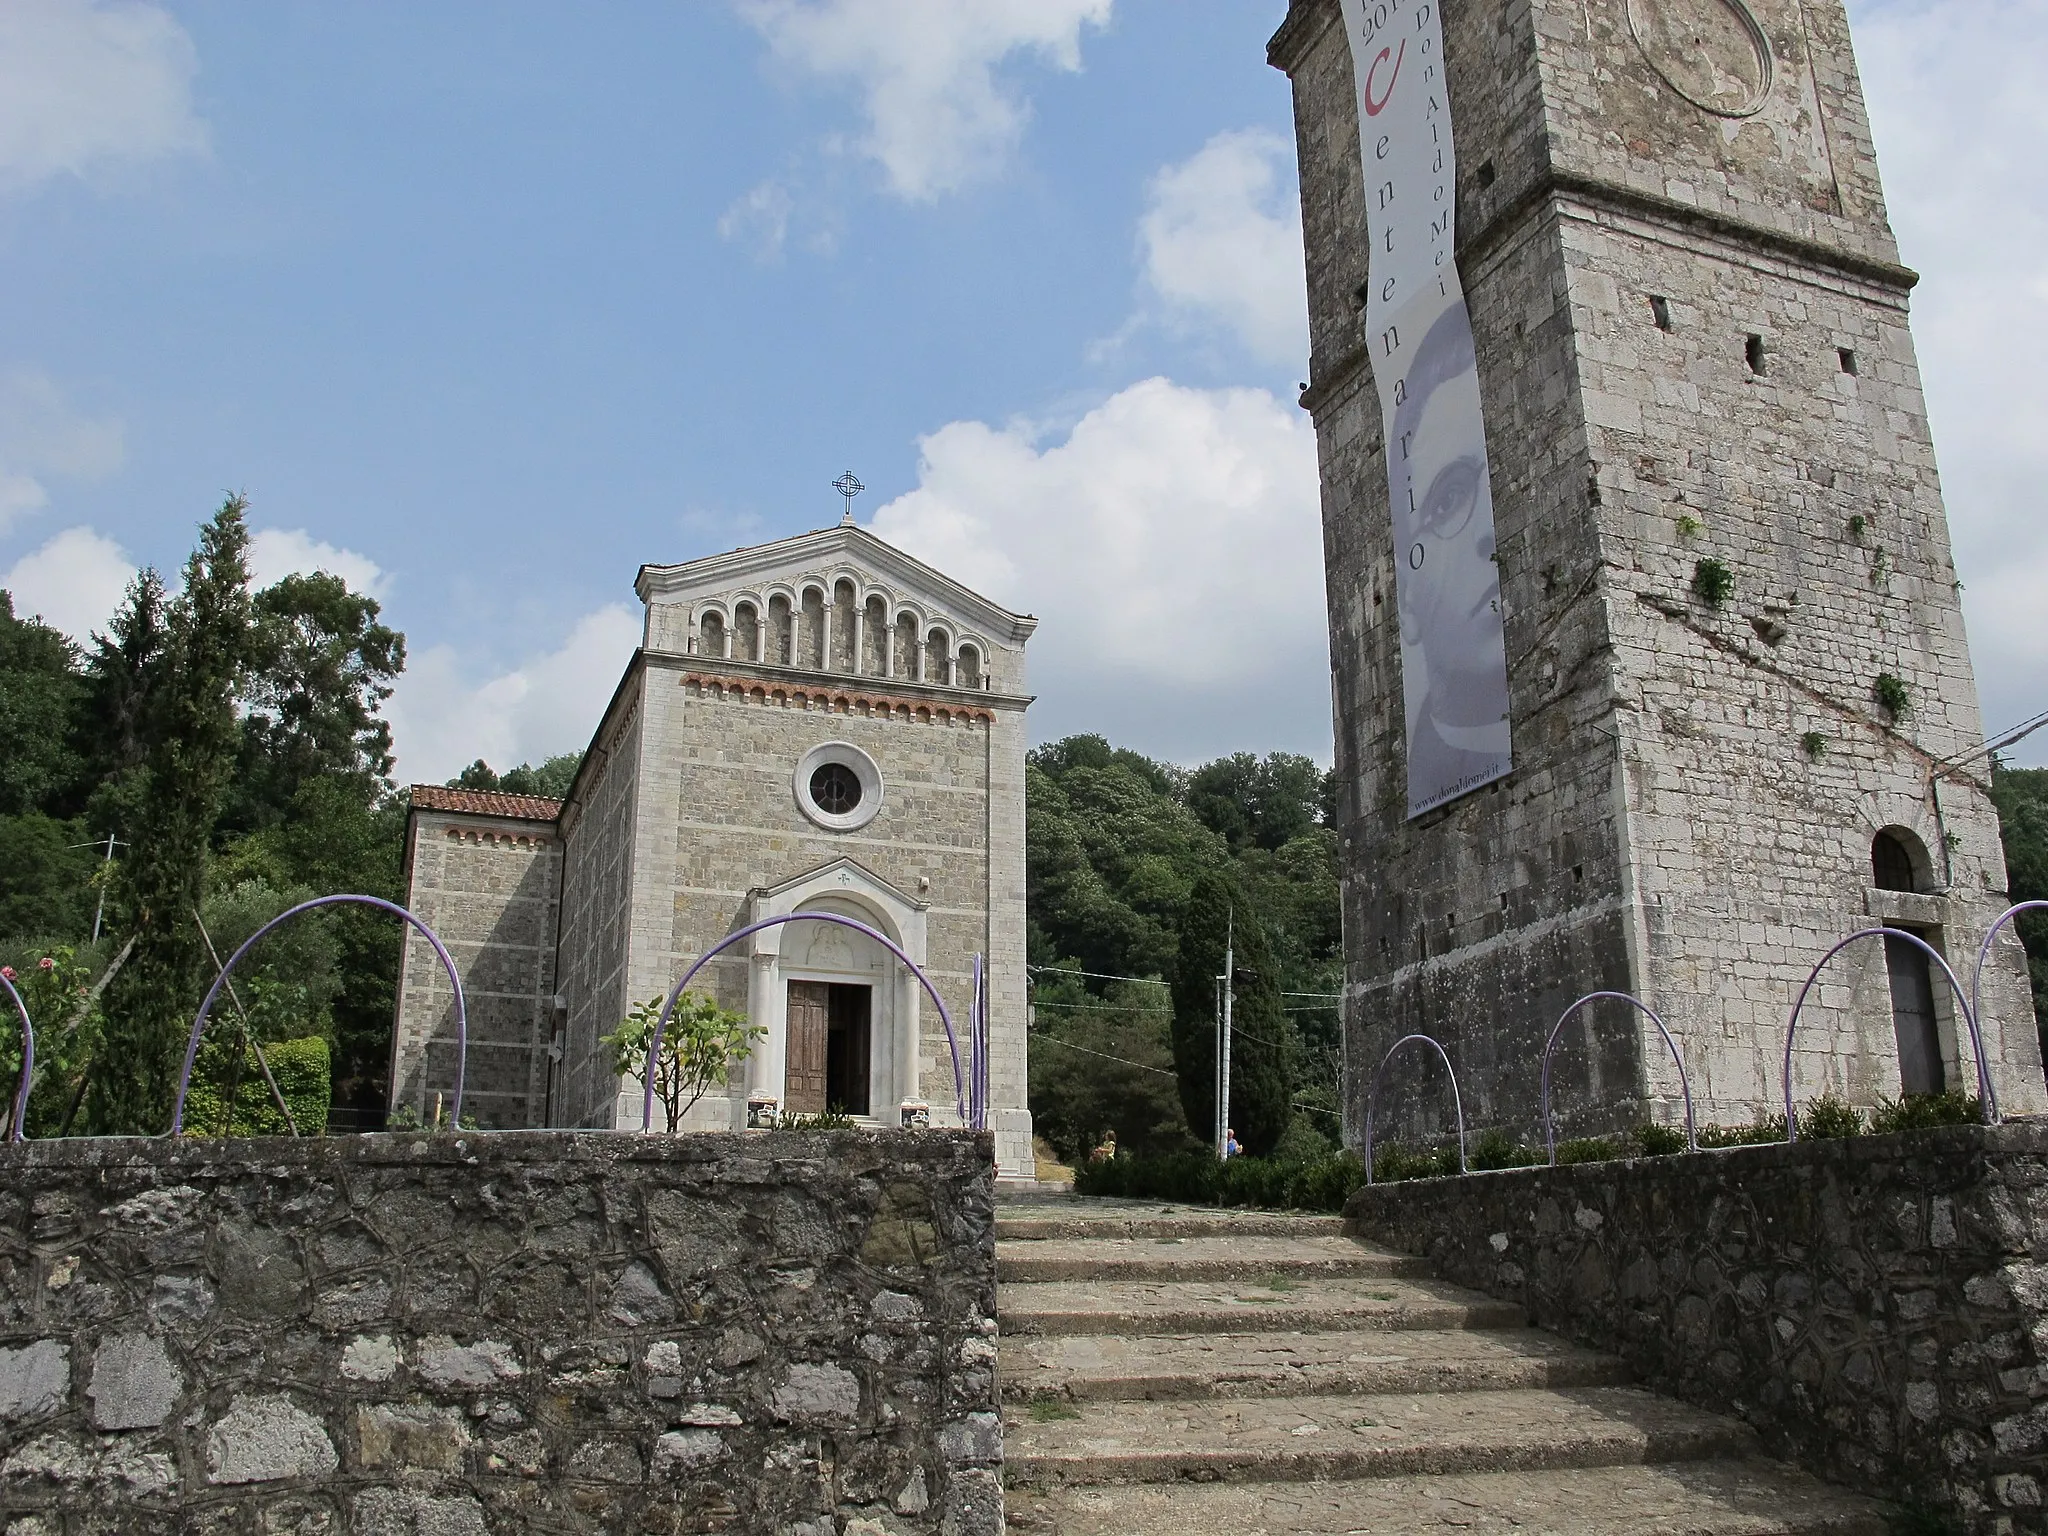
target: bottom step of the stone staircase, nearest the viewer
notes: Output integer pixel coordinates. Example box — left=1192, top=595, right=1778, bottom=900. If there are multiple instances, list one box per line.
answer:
left=1008, top=1460, right=1890, bottom=1536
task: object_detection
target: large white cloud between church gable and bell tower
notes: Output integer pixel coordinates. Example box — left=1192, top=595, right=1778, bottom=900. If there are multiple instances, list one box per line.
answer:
left=872, top=379, right=1329, bottom=758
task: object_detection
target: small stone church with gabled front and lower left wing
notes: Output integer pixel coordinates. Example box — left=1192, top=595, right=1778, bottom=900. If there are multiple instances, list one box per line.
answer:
left=389, top=522, right=1036, bottom=1178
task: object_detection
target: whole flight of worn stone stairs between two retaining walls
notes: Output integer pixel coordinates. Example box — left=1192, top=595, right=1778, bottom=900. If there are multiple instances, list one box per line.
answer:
left=995, top=1196, right=1888, bottom=1536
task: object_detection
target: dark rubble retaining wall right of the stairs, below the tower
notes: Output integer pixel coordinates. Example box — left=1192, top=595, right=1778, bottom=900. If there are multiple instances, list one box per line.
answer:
left=1346, top=1122, right=2048, bottom=1532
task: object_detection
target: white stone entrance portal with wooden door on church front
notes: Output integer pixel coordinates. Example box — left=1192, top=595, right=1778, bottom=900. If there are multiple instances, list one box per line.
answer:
left=748, top=860, right=926, bottom=1124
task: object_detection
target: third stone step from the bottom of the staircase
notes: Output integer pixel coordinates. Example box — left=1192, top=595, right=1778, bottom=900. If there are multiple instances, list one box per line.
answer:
left=995, top=1327, right=1628, bottom=1403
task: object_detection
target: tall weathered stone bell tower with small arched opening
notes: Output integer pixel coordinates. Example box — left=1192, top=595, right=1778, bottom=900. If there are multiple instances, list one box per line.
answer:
left=1268, top=0, right=2048, bottom=1141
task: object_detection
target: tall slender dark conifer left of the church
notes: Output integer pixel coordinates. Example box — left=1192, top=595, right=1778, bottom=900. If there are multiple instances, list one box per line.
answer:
left=88, top=496, right=250, bottom=1135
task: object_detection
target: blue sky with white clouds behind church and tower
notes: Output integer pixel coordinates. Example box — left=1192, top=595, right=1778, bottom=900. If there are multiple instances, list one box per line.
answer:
left=0, top=0, right=2048, bottom=778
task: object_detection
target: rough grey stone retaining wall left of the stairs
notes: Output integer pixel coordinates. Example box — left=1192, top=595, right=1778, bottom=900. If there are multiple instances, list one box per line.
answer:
left=0, top=1130, right=1004, bottom=1536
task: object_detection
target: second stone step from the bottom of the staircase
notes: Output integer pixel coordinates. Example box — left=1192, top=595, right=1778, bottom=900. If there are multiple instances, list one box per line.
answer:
left=1004, top=1386, right=1755, bottom=1490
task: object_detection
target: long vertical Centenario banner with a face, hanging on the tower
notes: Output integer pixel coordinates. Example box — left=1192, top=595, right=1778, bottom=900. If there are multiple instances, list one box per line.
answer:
left=1343, top=0, right=1513, bottom=817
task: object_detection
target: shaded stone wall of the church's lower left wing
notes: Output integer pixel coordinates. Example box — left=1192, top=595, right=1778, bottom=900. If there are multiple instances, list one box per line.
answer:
left=391, top=811, right=561, bottom=1128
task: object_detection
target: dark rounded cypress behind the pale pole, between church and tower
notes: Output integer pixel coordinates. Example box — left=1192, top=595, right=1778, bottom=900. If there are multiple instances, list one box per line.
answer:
left=1174, top=870, right=1294, bottom=1157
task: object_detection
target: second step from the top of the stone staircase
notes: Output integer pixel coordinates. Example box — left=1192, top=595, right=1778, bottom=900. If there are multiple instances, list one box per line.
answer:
left=995, top=1233, right=1430, bottom=1284
